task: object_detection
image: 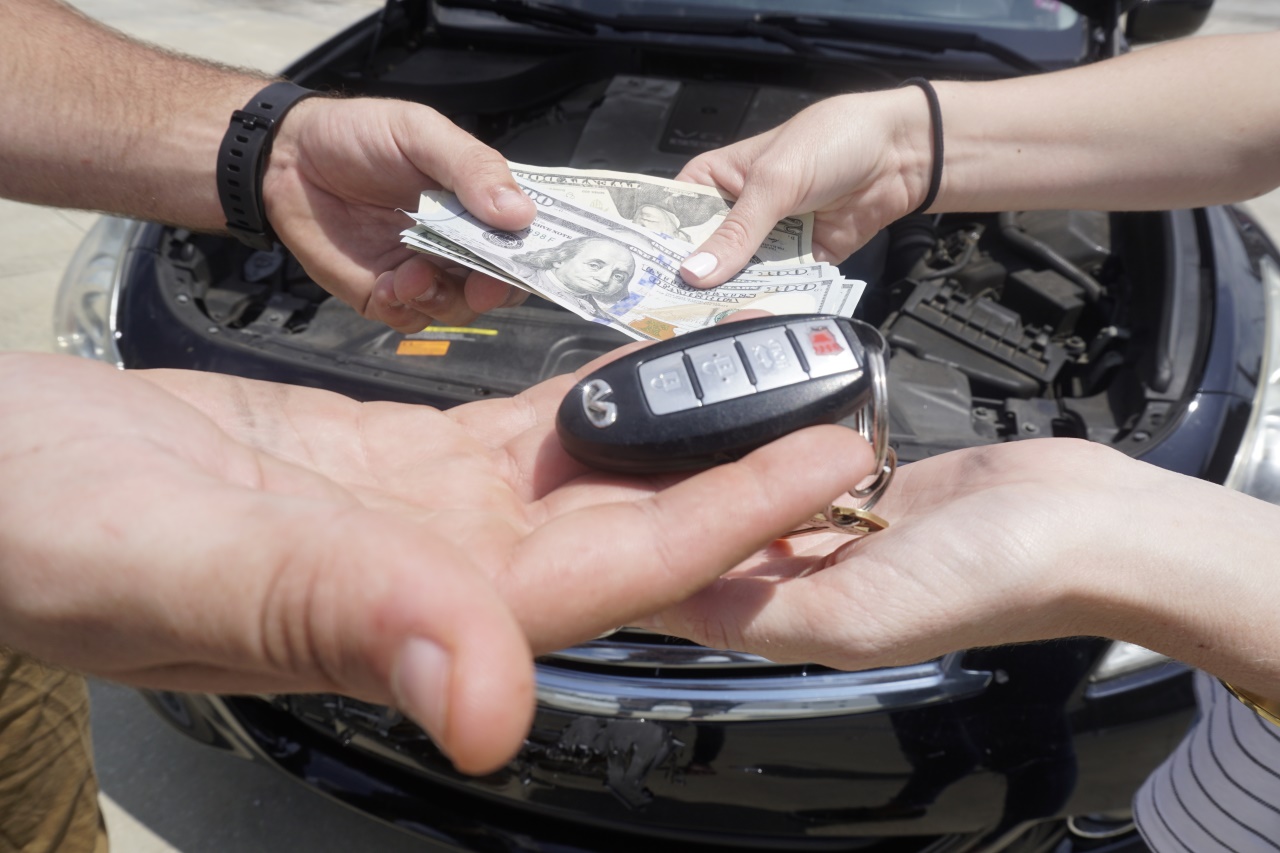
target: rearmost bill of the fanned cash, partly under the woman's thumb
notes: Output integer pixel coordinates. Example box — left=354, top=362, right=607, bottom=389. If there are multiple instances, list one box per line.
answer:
left=507, top=163, right=813, bottom=264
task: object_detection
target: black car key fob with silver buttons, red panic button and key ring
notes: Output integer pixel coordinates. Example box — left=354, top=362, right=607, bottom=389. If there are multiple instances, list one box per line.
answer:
left=556, top=315, right=896, bottom=535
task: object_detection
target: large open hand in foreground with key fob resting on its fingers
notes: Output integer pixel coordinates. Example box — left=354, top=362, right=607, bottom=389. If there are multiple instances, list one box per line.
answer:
left=0, top=353, right=872, bottom=772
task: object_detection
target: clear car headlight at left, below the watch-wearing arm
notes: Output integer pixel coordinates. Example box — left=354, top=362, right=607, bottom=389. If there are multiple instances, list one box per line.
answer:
left=54, top=216, right=140, bottom=368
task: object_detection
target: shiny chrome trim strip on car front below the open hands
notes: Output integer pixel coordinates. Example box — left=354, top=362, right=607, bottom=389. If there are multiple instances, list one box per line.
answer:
left=538, top=653, right=992, bottom=722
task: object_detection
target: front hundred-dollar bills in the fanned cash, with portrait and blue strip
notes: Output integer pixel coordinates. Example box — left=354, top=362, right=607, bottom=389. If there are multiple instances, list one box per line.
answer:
left=403, top=175, right=863, bottom=339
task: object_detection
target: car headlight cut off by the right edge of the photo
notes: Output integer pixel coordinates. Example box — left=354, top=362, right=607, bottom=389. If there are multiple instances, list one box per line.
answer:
left=1226, top=255, right=1280, bottom=503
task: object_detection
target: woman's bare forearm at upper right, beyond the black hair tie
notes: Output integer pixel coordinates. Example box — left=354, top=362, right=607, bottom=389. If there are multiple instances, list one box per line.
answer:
left=926, top=33, right=1280, bottom=213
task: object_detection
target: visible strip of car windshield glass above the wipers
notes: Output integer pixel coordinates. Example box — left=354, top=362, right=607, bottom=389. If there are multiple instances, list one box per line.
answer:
left=529, top=0, right=1079, bottom=31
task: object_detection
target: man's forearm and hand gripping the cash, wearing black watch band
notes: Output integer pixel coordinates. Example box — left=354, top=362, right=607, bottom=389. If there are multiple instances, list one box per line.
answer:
left=0, top=0, right=534, bottom=332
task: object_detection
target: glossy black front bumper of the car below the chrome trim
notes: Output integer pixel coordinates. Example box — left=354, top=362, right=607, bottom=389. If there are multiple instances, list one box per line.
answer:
left=150, top=640, right=1193, bottom=852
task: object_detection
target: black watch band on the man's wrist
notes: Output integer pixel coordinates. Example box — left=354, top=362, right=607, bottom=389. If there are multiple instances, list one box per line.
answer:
left=218, top=82, right=319, bottom=251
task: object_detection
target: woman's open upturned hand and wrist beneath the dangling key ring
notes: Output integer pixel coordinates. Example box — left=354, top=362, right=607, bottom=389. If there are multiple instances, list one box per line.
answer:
left=644, top=438, right=1280, bottom=697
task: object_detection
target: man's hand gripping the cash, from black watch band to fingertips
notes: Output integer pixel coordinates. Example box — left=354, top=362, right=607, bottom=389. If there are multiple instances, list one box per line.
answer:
left=262, top=97, right=534, bottom=333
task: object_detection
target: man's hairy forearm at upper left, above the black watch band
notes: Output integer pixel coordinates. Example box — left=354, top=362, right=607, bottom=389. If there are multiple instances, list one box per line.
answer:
left=0, top=0, right=266, bottom=229
